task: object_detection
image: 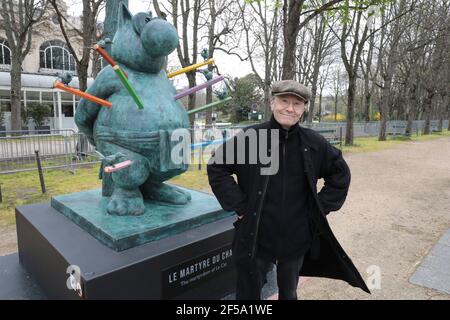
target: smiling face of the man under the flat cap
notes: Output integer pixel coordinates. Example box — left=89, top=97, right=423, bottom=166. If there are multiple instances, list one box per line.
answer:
left=270, top=94, right=306, bottom=129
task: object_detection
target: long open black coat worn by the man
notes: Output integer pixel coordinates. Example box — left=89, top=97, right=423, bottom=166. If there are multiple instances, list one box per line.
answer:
left=207, top=122, right=370, bottom=293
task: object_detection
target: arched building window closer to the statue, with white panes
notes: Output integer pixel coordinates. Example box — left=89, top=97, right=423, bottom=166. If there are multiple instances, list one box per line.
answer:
left=39, top=40, right=75, bottom=71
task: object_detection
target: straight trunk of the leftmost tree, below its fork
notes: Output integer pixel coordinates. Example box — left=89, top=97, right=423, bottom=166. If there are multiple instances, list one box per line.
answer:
left=10, top=56, right=22, bottom=130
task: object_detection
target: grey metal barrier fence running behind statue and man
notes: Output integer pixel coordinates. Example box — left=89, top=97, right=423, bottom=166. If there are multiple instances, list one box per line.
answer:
left=0, top=120, right=448, bottom=173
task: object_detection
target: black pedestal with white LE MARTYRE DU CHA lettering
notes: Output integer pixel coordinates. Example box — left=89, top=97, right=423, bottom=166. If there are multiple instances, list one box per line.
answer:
left=16, top=203, right=235, bottom=299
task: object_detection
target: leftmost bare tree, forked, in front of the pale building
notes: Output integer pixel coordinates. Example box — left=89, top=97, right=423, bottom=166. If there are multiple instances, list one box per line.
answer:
left=0, top=0, right=47, bottom=130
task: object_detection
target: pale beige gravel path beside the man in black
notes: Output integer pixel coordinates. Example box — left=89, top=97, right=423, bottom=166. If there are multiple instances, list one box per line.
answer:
left=0, top=138, right=450, bottom=300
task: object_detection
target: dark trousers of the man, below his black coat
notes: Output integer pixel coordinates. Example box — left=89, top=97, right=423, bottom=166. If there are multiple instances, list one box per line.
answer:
left=236, top=256, right=303, bottom=300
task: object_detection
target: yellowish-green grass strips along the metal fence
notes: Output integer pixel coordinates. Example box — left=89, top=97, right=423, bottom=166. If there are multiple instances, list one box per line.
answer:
left=0, top=130, right=450, bottom=227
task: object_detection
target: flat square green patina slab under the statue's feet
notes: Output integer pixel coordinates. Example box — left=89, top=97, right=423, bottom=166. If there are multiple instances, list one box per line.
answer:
left=51, top=189, right=234, bottom=251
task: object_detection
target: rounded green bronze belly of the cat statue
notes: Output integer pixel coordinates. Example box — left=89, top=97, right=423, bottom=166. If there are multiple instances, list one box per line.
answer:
left=94, top=70, right=189, bottom=181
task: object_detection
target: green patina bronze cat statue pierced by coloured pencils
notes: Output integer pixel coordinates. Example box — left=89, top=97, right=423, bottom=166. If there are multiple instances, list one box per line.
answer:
left=75, top=4, right=191, bottom=216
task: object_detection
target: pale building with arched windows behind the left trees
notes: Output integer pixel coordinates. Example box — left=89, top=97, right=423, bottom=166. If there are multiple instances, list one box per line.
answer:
left=0, top=0, right=93, bottom=130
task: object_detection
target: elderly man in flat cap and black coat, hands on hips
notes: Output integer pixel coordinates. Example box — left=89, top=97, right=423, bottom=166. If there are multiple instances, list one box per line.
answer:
left=207, top=80, right=369, bottom=300
